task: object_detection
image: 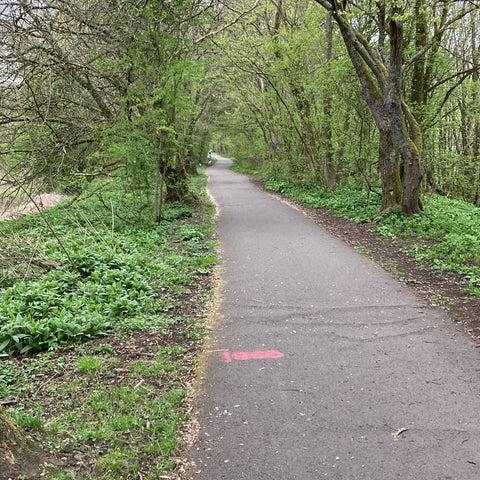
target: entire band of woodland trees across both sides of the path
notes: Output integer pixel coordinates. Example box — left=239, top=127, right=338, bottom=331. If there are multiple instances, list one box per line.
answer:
left=0, top=0, right=480, bottom=217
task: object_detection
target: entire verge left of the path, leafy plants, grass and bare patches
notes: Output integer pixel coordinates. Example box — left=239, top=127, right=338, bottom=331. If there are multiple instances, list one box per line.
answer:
left=0, top=179, right=217, bottom=480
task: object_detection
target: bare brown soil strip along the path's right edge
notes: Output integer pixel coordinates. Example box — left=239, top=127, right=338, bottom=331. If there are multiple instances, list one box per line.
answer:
left=249, top=175, right=480, bottom=341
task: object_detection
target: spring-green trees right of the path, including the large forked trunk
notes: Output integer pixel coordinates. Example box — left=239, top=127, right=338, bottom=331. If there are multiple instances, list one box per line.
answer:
left=204, top=0, right=479, bottom=215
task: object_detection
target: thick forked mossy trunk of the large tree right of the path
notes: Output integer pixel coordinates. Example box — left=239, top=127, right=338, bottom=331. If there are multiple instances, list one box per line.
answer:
left=316, top=0, right=422, bottom=215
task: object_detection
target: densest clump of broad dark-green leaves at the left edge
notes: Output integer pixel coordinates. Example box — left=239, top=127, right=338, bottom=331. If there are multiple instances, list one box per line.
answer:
left=0, top=248, right=152, bottom=353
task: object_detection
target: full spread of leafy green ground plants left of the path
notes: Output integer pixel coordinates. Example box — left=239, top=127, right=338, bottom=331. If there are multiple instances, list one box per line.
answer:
left=0, top=180, right=217, bottom=355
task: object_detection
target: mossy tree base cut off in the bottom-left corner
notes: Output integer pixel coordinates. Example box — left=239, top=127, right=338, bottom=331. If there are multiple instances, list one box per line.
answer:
left=0, top=406, right=44, bottom=480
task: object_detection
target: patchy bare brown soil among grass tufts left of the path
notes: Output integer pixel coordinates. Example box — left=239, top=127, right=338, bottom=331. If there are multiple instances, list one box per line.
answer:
left=0, top=274, right=214, bottom=480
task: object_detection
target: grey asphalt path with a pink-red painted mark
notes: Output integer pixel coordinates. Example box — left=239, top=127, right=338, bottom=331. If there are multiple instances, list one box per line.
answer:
left=189, top=158, right=480, bottom=480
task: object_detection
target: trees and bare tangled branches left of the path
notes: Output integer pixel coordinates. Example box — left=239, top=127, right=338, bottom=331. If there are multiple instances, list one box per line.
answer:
left=0, top=0, right=218, bottom=221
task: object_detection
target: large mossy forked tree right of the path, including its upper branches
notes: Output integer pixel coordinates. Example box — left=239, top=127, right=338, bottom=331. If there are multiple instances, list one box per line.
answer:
left=316, top=0, right=479, bottom=215
